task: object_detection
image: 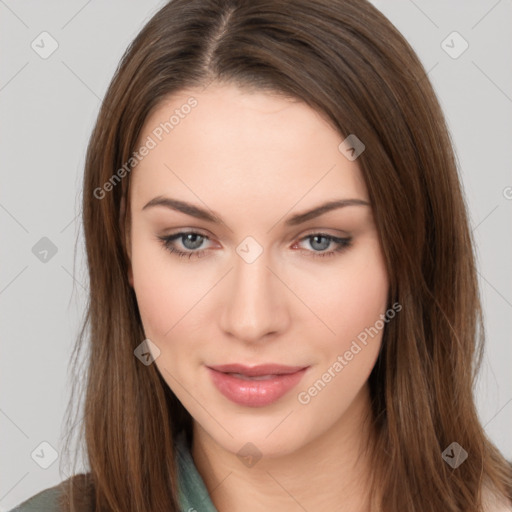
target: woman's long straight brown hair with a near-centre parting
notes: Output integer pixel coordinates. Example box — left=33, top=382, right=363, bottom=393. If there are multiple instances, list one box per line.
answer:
left=61, top=0, right=512, bottom=512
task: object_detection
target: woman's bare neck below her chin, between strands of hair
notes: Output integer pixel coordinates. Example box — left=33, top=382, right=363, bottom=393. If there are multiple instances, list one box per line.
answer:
left=192, top=386, right=374, bottom=512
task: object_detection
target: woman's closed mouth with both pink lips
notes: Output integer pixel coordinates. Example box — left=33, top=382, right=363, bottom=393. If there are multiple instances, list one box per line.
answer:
left=206, top=363, right=309, bottom=407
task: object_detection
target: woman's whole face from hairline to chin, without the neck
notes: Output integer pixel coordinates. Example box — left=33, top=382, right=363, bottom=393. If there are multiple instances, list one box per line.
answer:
left=128, top=85, right=388, bottom=455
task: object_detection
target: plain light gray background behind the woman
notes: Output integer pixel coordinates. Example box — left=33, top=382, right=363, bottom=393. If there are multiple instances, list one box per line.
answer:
left=0, top=0, right=512, bottom=511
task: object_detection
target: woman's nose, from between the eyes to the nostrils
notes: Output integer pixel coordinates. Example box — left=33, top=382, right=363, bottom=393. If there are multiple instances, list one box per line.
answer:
left=219, top=251, right=290, bottom=343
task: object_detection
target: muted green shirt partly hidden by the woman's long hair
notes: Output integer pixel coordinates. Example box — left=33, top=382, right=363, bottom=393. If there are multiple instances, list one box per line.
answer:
left=6, top=431, right=218, bottom=512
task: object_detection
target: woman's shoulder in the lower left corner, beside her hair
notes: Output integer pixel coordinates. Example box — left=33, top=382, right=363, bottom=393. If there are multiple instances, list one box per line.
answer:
left=10, top=473, right=94, bottom=512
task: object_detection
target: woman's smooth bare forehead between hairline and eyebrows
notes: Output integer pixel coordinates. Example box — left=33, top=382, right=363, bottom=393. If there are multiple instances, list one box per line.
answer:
left=131, top=85, right=368, bottom=210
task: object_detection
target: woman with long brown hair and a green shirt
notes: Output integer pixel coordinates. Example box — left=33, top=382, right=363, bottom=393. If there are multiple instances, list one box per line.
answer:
left=9, top=0, right=512, bottom=512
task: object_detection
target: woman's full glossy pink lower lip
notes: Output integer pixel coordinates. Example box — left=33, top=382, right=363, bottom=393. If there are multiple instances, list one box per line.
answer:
left=208, top=368, right=307, bottom=407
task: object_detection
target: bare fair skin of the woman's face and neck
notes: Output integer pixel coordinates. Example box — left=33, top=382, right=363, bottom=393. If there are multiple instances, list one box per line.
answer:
left=127, top=84, right=389, bottom=512
